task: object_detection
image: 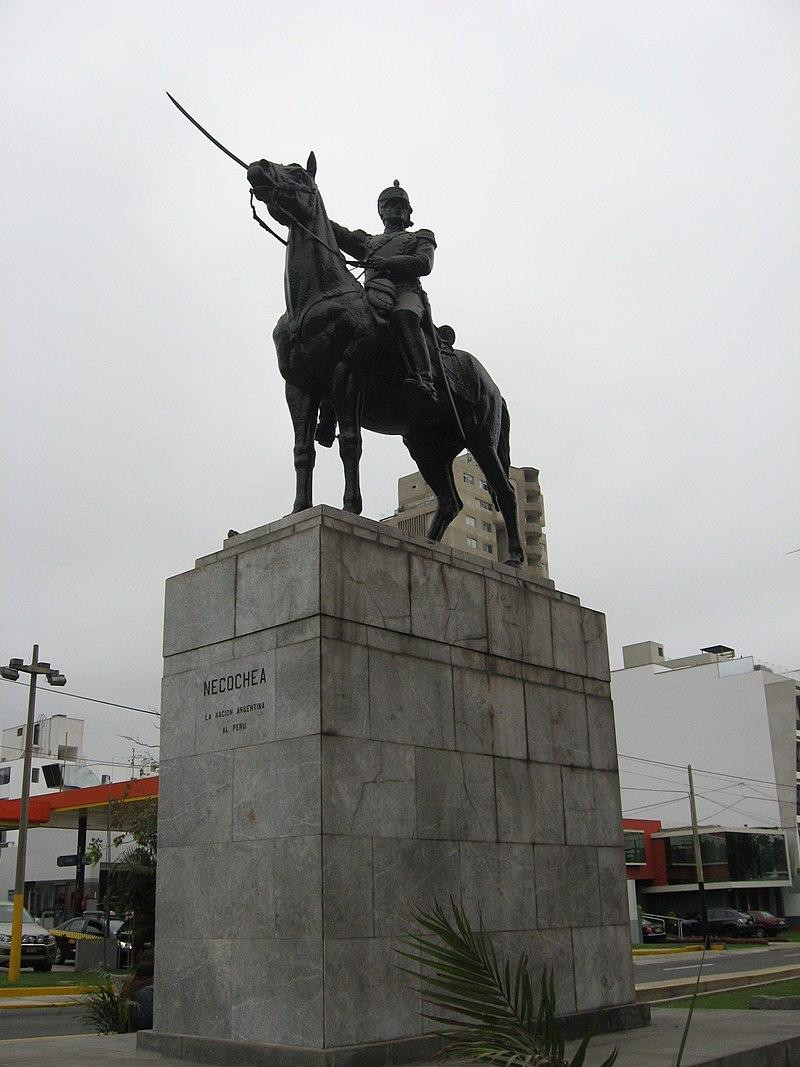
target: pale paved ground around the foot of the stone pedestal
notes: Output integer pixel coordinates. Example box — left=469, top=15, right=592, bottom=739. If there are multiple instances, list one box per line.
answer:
left=0, top=1008, right=800, bottom=1067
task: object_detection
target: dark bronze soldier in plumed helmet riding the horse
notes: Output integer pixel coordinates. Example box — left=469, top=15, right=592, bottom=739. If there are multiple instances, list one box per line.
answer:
left=331, top=179, right=438, bottom=402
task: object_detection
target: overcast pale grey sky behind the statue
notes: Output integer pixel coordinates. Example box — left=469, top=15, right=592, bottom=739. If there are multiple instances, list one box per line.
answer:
left=0, top=0, right=800, bottom=768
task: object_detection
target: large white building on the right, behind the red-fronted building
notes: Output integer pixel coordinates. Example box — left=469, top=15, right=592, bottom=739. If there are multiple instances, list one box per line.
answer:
left=611, top=641, right=800, bottom=915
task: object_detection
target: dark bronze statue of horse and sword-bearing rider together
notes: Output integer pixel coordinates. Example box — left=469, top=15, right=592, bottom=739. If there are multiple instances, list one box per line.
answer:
left=167, top=94, right=525, bottom=564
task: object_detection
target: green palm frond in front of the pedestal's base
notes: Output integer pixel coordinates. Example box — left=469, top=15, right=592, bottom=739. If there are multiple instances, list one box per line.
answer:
left=397, top=897, right=617, bottom=1067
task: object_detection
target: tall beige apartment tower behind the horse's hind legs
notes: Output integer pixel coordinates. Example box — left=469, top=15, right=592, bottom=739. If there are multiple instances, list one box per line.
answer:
left=382, top=452, right=549, bottom=578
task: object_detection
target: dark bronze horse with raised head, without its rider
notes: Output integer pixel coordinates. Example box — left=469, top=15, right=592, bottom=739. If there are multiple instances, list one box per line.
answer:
left=247, top=153, right=524, bottom=564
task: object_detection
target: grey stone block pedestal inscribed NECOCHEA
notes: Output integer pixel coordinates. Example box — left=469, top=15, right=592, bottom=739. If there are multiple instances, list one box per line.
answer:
left=140, top=507, right=646, bottom=1065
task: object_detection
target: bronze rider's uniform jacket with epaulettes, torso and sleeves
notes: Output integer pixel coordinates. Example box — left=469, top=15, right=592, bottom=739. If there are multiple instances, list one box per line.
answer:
left=331, top=221, right=436, bottom=318
